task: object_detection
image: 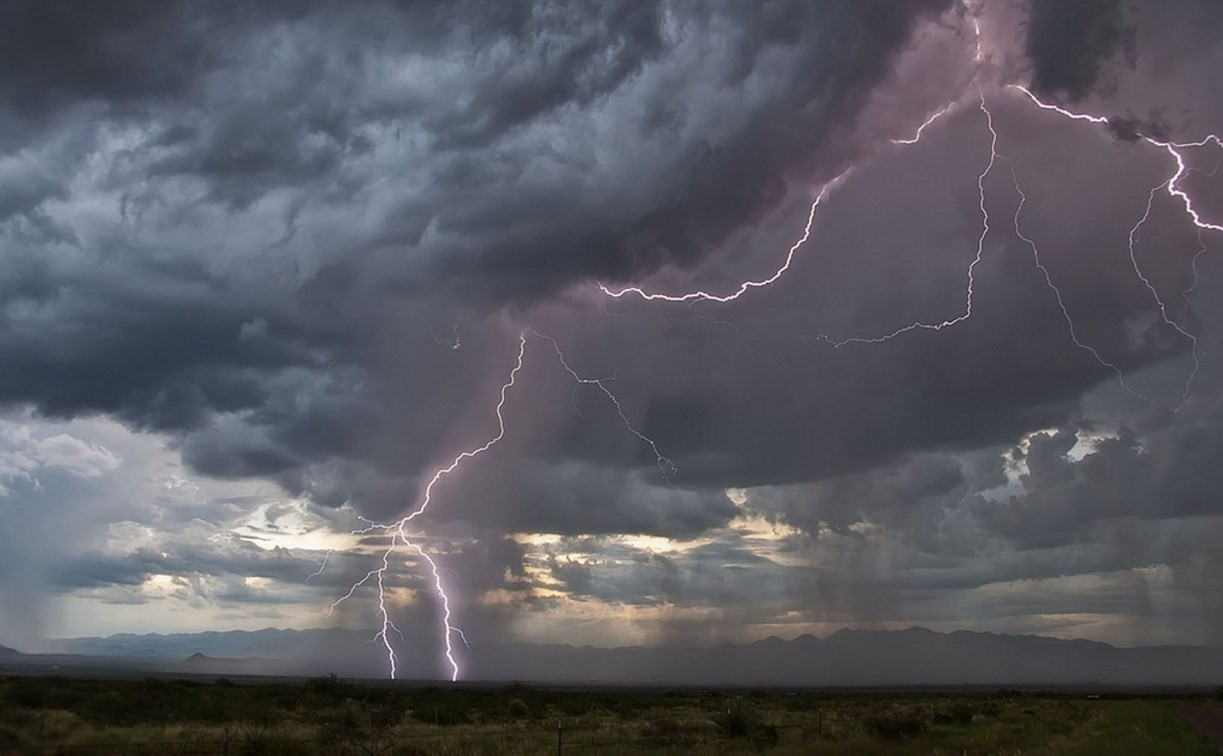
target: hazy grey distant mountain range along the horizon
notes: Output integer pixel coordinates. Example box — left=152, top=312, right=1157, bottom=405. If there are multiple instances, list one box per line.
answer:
left=0, top=628, right=1223, bottom=687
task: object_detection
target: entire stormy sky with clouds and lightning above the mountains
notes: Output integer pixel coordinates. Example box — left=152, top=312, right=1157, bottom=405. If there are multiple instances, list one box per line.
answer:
left=0, top=0, right=1223, bottom=670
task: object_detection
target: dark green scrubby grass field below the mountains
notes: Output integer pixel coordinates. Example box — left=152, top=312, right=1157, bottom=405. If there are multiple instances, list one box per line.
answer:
left=0, top=678, right=1223, bottom=756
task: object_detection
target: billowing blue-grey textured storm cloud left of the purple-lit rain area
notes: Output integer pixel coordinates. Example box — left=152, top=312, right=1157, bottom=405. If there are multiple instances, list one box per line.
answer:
left=0, top=1, right=947, bottom=500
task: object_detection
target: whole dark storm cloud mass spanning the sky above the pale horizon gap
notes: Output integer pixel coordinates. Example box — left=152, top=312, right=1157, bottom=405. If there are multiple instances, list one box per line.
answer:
left=7, top=0, right=1223, bottom=645
